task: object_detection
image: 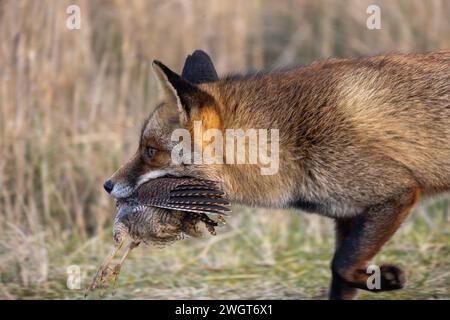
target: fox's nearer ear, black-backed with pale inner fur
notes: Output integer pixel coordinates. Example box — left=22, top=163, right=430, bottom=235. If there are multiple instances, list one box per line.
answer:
left=152, top=60, right=213, bottom=124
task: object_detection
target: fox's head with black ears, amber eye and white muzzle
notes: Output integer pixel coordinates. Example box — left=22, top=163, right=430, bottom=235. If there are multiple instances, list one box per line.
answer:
left=104, top=51, right=220, bottom=198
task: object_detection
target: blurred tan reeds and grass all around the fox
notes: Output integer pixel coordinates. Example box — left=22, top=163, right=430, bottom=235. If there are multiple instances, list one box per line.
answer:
left=0, top=0, right=450, bottom=299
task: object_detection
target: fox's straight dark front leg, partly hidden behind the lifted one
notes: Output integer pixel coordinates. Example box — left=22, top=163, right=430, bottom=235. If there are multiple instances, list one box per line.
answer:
left=330, top=218, right=358, bottom=300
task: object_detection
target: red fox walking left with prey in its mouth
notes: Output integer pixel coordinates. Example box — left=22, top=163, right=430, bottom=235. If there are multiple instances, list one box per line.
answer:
left=104, top=50, right=450, bottom=300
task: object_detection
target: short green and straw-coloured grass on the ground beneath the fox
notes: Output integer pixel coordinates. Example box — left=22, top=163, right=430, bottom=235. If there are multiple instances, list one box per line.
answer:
left=0, top=200, right=450, bottom=299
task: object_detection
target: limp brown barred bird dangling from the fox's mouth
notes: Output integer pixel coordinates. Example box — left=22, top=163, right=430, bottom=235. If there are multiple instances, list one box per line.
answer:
left=85, top=177, right=230, bottom=296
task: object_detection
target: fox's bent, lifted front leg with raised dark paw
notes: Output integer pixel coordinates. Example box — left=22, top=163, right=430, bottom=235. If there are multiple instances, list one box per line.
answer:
left=331, top=188, right=420, bottom=299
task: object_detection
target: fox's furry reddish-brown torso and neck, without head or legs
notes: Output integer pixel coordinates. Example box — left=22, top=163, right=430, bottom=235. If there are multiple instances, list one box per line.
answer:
left=199, top=52, right=450, bottom=212
